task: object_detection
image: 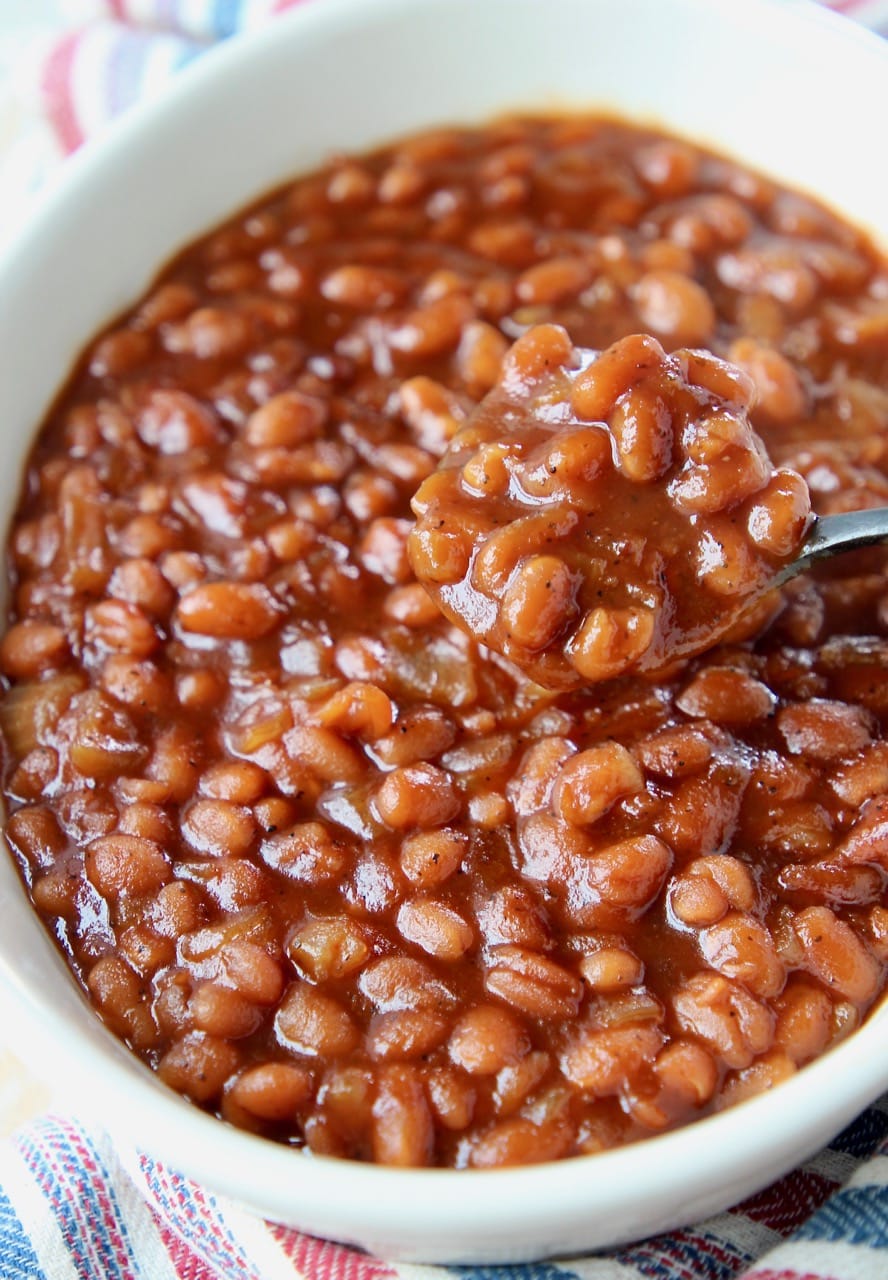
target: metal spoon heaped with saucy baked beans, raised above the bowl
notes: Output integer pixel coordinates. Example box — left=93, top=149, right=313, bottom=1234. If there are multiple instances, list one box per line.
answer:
left=408, top=324, right=888, bottom=690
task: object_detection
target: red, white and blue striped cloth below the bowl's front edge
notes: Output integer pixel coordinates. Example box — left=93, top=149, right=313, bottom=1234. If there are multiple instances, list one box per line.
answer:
left=0, top=1098, right=888, bottom=1280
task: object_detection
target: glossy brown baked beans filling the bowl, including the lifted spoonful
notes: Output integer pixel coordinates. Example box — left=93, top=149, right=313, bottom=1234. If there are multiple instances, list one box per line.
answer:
left=0, top=118, right=888, bottom=1167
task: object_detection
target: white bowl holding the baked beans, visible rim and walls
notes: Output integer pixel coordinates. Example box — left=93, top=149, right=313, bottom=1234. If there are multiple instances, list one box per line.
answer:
left=0, top=0, right=888, bottom=1262
